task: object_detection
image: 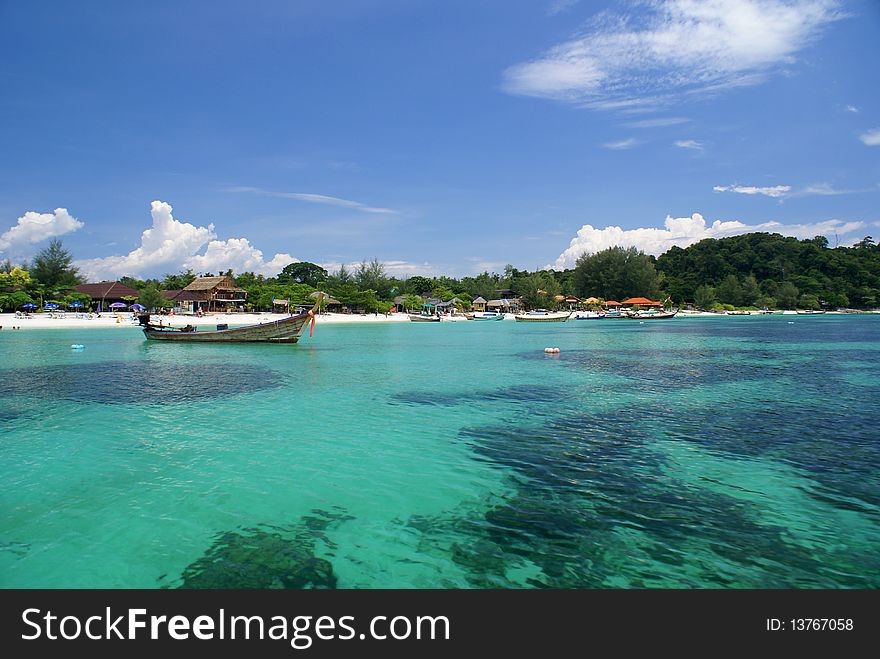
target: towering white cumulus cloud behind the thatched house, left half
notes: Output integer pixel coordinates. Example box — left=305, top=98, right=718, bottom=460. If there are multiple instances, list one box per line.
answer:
left=76, top=201, right=296, bottom=281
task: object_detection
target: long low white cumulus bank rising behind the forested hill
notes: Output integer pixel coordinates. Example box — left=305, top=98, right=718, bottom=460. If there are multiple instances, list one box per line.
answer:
left=547, top=213, right=865, bottom=270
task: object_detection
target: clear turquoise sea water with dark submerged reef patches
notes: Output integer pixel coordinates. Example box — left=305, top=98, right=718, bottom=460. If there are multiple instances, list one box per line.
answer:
left=0, top=316, right=880, bottom=588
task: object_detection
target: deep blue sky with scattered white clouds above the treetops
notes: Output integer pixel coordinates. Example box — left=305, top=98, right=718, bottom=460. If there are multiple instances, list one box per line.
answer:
left=0, top=0, right=880, bottom=279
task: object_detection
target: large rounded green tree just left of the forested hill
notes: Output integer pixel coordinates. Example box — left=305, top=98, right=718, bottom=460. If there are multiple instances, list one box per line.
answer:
left=572, top=247, right=659, bottom=300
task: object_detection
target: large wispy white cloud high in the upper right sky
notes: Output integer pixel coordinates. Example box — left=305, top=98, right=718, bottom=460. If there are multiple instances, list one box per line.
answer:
left=504, top=0, right=841, bottom=109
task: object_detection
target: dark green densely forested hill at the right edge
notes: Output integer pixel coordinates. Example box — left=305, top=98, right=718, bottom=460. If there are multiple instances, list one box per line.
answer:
left=656, top=233, right=880, bottom=308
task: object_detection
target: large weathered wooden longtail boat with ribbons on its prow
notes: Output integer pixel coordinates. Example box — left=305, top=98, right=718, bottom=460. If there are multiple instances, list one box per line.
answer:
left=138, top=297, right=321, bottom=343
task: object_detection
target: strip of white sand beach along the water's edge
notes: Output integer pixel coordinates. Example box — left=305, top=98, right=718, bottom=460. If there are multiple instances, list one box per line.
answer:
left=0, top=310, right=880, bottom=330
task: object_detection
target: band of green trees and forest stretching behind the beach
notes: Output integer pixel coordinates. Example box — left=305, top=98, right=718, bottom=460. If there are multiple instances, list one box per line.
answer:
left=0, top=233, right=880, bottom=312
